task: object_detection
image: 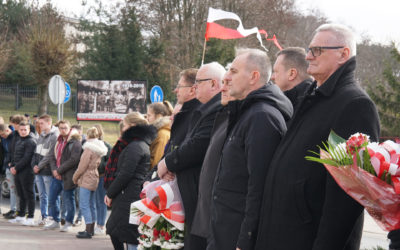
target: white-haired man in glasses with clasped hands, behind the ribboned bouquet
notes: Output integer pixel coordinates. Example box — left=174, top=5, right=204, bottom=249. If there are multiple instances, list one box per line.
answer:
left=158, top=62, right=225, bottom=249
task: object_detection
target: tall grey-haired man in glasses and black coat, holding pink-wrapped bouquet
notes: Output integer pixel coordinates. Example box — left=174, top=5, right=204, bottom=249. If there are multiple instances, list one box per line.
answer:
left=256, top=24, right=380, bottom=250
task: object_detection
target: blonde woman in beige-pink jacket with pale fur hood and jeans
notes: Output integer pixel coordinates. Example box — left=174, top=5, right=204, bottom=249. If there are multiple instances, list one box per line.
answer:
left=72, top=127, right=107, bottom=239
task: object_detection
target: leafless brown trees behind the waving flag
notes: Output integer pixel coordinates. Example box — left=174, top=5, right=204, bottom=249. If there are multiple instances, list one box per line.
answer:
left=130, top=0, right=304, bottom=89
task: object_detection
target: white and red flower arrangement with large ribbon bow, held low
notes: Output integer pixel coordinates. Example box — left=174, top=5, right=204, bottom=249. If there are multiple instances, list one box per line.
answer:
left=129, top=178, right=185, bottom=250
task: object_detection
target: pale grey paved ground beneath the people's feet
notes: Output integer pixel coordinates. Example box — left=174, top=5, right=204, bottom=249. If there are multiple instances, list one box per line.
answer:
left=0, top=199, right=389, bottom=250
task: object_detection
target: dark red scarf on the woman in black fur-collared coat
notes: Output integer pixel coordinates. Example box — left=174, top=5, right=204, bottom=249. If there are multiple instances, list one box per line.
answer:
left=104, top=137, right=138, bottom=189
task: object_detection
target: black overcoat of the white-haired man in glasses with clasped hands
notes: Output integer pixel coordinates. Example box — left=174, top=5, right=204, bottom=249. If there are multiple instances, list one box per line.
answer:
left=165, top=93, right=222, bottom=250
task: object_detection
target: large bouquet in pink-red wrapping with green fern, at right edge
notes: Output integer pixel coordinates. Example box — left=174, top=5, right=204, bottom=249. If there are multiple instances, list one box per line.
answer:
left=305, top=131, right=400, bottom=231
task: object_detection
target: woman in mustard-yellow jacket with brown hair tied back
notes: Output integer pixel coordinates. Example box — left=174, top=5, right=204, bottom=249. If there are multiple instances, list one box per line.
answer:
left=147, top=101, right=173, bottom=168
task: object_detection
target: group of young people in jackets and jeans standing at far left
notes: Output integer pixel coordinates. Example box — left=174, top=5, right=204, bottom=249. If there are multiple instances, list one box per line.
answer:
left=0, top=114, right=111, bottom=238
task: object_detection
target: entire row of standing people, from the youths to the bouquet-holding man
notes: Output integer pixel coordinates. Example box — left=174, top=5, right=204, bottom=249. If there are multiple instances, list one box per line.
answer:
left=0, top=24, right=400, bottom=250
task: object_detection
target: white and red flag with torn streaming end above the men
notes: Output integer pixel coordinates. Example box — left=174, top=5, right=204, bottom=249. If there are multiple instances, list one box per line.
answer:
left=205, top=7, right=282, bottom=50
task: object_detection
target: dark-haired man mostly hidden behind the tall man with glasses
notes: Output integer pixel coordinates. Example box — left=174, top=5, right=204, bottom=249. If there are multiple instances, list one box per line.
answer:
left=271, top=47, right=312, bottom=110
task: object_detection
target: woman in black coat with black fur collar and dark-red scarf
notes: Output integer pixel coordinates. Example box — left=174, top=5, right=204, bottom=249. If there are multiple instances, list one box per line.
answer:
left=104, top=112, right=157, bottom=250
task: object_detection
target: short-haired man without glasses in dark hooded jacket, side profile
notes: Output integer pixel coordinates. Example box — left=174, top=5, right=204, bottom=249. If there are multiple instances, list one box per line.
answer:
left=208, top=49, right=293, bottom=250
